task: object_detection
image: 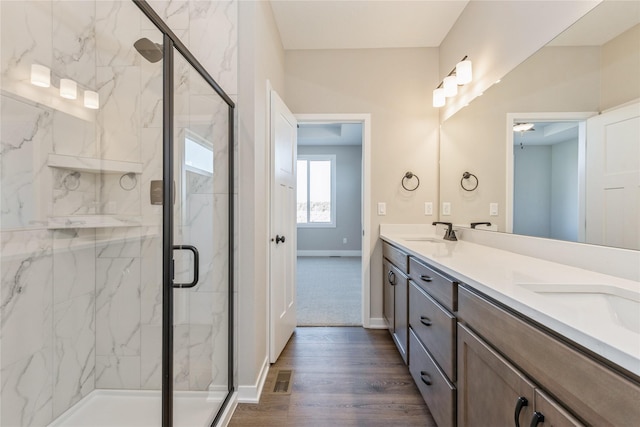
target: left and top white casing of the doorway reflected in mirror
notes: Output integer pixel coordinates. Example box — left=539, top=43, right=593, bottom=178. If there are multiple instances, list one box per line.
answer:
left=504, top=112, right=598, bottom=233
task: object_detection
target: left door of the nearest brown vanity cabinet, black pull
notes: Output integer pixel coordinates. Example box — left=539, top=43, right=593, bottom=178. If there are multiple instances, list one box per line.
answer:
left=458, top=324, right=535, bottom=427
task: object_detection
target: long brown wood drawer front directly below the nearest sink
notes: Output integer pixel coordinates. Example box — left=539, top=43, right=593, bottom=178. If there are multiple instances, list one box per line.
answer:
left=458, top=287, right=640, bottom=426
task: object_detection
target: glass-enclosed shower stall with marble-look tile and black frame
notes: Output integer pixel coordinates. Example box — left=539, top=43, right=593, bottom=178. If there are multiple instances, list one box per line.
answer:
left=0, top=0, right=234, bottom=427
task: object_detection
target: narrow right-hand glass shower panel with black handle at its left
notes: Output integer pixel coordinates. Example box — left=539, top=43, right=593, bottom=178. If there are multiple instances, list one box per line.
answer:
left=173, top=46, right=229, bottom=426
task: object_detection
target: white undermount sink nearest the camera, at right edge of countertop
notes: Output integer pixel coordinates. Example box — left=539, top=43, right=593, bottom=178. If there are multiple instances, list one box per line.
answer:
left=521, top=284, right=640, bottom=334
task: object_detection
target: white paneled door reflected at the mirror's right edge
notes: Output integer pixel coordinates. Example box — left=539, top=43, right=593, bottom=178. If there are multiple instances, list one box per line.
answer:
left=586, top=103, right=640, bottom=249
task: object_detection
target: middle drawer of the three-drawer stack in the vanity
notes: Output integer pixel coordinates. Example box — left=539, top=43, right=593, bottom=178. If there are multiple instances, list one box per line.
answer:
left=409, top=281, right=456, bottom=382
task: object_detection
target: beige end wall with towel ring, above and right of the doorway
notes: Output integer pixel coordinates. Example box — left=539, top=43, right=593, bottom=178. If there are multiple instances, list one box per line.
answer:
left=285, top=48, right=438, bottom=318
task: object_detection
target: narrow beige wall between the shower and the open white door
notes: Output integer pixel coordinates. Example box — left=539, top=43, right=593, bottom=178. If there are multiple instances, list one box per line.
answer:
left=236, top=1, right=284, bottom=399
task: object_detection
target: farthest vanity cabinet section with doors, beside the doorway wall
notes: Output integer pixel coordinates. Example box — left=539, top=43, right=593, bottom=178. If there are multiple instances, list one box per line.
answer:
left=382, top=243, right=409, bottom=363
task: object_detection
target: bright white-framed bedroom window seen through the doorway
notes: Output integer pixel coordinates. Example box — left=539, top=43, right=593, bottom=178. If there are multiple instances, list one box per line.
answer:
left=297, top=154, right=336, bottom=227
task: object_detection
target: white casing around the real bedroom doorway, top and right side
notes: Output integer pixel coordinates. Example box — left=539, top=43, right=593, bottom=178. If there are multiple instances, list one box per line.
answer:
left=295, top=113, right=374, bottom=328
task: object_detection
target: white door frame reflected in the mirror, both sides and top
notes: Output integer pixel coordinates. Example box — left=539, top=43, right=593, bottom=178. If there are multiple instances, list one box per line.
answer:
left=504, top=112, right=597, bottom=237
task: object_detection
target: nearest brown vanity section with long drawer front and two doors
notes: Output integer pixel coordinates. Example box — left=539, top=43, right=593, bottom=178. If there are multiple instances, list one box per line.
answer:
left=457, top=287, right=640, bottom=426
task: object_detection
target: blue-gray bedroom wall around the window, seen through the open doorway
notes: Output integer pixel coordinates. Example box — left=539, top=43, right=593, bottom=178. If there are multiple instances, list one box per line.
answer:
left=298, top=145, right=362, bottom=254
